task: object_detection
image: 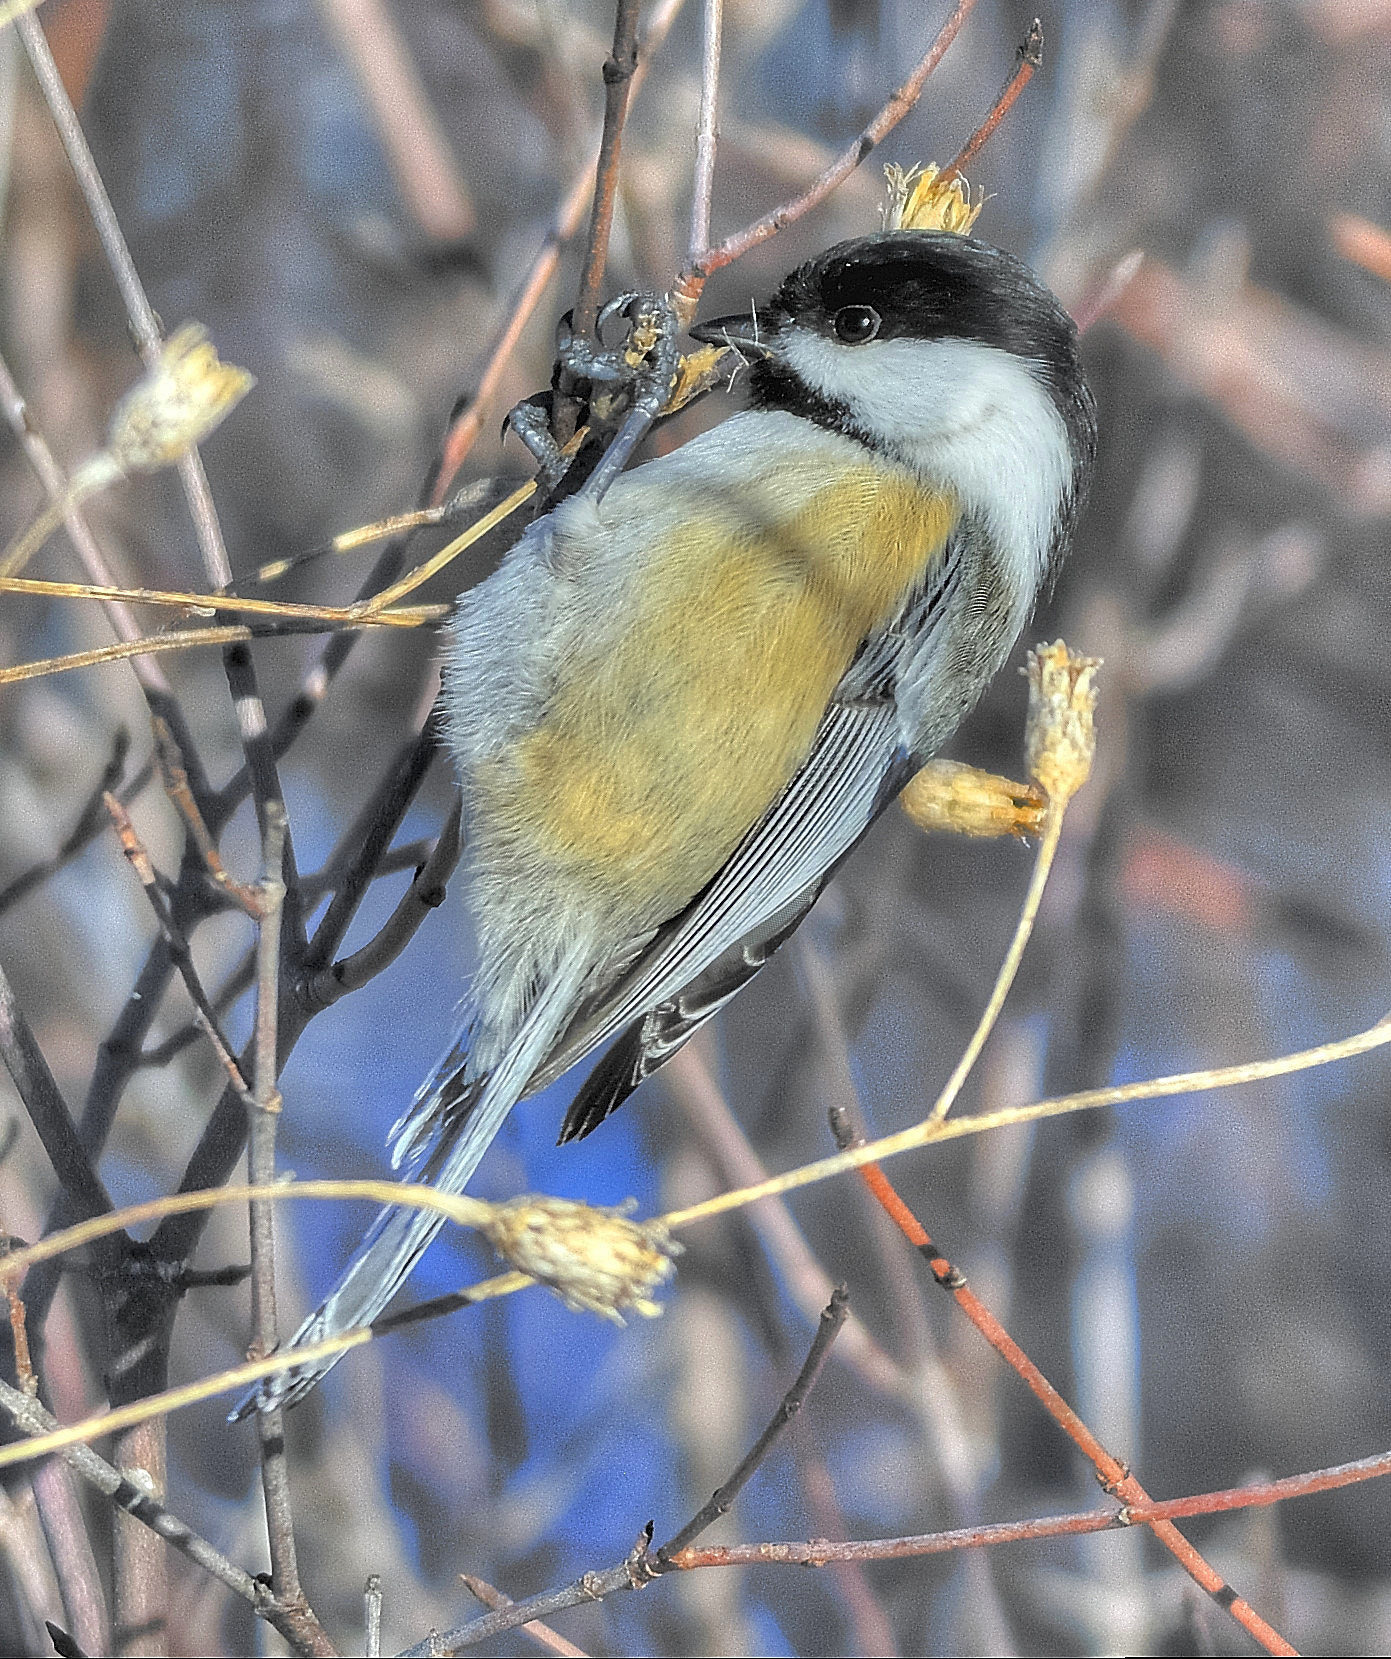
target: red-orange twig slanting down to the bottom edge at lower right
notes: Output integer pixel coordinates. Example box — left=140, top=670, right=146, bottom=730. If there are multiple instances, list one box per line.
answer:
left=832, top=1117, right=1295, bottom=1654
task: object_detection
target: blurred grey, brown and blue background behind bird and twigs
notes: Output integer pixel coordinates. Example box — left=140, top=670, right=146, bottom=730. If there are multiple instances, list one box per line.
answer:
left=0, top=0, right=1391, bottom=1654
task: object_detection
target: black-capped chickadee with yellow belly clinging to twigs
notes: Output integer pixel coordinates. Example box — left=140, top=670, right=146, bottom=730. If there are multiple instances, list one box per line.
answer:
left=247, top=231, right=1096, bottom=1404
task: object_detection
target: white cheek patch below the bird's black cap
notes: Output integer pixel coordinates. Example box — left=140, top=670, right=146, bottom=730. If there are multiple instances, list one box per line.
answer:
left=777, top=327, right=1072, bottom=599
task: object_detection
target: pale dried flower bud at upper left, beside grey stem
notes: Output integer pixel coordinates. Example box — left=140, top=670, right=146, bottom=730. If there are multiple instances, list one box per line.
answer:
left=106, top=322, right=256, bottom=473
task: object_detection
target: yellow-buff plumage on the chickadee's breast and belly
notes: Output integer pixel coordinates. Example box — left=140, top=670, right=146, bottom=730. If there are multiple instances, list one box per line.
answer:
left=473, top=466, right=956, bottom=927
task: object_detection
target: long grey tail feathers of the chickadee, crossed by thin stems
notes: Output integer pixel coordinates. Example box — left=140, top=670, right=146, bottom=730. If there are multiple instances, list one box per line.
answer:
left=229, top=944, right=591, bottom=1422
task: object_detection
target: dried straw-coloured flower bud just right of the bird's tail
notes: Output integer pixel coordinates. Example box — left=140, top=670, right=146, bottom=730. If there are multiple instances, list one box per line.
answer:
left=483, top=1198, right=681, bottom=1326
